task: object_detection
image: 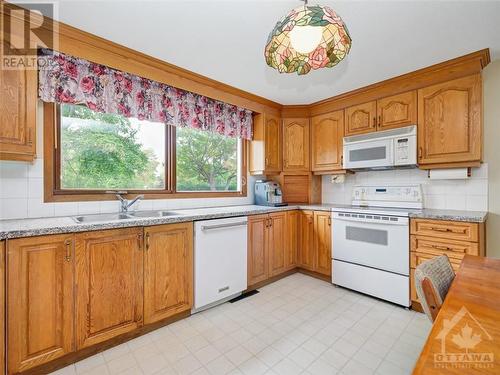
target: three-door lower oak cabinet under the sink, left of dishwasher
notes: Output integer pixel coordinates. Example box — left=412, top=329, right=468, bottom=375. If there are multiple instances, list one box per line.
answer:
left=5, top=223, right=193, bottom=374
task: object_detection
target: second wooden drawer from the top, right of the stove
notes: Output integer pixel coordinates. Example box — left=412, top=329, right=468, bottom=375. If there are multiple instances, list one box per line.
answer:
left=410, top=235, right=479, bottom=260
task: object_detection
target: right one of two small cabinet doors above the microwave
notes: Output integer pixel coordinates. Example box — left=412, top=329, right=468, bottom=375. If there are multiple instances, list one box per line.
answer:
left=377, top=91, right=417, bottom=130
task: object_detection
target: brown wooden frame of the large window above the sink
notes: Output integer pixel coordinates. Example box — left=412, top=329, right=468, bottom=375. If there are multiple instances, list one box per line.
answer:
left=43, top=102, right=248, bottom=202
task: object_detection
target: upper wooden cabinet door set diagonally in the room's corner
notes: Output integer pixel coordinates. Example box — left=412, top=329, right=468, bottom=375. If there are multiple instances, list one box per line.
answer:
left=283, top=118, right=309, bottom=172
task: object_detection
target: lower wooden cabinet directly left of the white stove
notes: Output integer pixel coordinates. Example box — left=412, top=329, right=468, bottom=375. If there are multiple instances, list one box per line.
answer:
left=299, top=211, right=332, bottom=276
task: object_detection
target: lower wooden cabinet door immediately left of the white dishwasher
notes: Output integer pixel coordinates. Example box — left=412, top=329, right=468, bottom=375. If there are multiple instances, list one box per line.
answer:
left=144, top=223, right=193, bottom=324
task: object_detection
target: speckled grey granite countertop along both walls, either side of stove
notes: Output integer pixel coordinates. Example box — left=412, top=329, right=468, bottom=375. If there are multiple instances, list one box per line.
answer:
left=0, top=204, right=487, bottom=240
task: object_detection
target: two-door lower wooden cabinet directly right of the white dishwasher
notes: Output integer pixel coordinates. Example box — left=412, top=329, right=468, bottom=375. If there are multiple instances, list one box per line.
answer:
left=248, top=211, right=299, bottom=286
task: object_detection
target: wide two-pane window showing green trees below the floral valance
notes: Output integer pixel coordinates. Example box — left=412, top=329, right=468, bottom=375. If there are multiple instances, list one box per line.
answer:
left=45, top=104, right=246, bottom=201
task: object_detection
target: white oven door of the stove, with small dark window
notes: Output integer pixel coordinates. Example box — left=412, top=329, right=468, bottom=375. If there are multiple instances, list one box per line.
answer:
left=332, top=212, right=410, bottom=276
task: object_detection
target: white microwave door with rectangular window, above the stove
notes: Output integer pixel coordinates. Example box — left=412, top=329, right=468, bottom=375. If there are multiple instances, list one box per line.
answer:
left=344, top=138, right=394, bottom=169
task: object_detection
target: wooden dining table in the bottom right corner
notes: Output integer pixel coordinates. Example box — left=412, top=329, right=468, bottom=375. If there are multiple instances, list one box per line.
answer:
left=413, top=255, right=500, bottom=375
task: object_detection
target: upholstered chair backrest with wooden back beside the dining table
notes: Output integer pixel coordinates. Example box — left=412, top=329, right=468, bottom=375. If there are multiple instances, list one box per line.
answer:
left=415, top=255, right=455, bottom=322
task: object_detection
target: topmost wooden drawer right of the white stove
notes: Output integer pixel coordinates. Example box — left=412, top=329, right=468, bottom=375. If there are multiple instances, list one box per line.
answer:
left=410, top=219, right=479, bottom=242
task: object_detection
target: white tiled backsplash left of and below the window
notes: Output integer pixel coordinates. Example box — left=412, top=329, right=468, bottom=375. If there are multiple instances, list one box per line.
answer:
left=0, top=101, right=255, bottom=219
